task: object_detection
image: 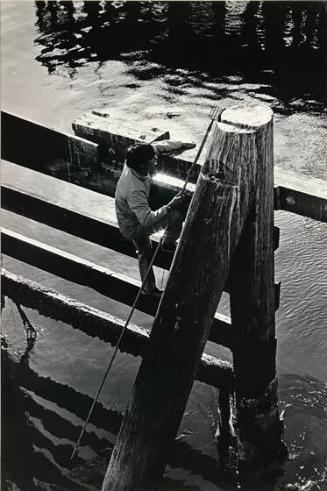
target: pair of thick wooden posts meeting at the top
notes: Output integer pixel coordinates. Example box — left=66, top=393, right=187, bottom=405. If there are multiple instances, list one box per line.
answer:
left=102, top=106, right=283, bottom=491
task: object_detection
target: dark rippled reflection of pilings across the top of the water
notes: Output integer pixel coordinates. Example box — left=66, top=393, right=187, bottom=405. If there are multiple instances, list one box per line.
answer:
left=35, top=1, right=327, bottom=110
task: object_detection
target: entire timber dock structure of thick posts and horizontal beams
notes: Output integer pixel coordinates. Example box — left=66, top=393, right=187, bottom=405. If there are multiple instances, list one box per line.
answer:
left=2, top=105, right=327, bottom=491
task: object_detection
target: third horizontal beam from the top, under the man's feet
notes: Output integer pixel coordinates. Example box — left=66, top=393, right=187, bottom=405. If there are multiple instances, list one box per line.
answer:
left=1, top=234, right=233, bottom=348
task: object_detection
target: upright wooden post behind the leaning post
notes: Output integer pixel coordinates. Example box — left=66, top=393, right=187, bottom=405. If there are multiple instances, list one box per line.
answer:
left=227, top=107, right=285, bottom=468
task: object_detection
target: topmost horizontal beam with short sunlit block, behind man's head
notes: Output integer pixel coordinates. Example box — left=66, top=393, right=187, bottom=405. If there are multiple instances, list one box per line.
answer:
left=1, top=111, right=327, bottom=222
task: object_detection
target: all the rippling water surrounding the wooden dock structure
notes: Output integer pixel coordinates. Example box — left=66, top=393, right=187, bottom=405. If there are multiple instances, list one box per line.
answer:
left=1, top=1, right=327, bottom=491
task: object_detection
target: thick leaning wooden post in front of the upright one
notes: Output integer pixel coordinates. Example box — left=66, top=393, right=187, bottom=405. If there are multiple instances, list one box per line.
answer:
left=102, top=107, right=271, bottom=491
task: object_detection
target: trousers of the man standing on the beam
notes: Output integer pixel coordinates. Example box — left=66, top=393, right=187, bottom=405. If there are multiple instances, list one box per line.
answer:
left=132, top=211, right=184, bottom=292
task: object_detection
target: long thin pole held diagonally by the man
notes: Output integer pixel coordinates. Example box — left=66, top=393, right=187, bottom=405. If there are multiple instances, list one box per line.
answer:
left=70, top=107, right=221, bottom=460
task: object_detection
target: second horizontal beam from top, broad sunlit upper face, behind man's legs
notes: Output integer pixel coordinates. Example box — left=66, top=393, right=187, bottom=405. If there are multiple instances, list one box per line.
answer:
left=1, top=161, right=278, bottom=298
